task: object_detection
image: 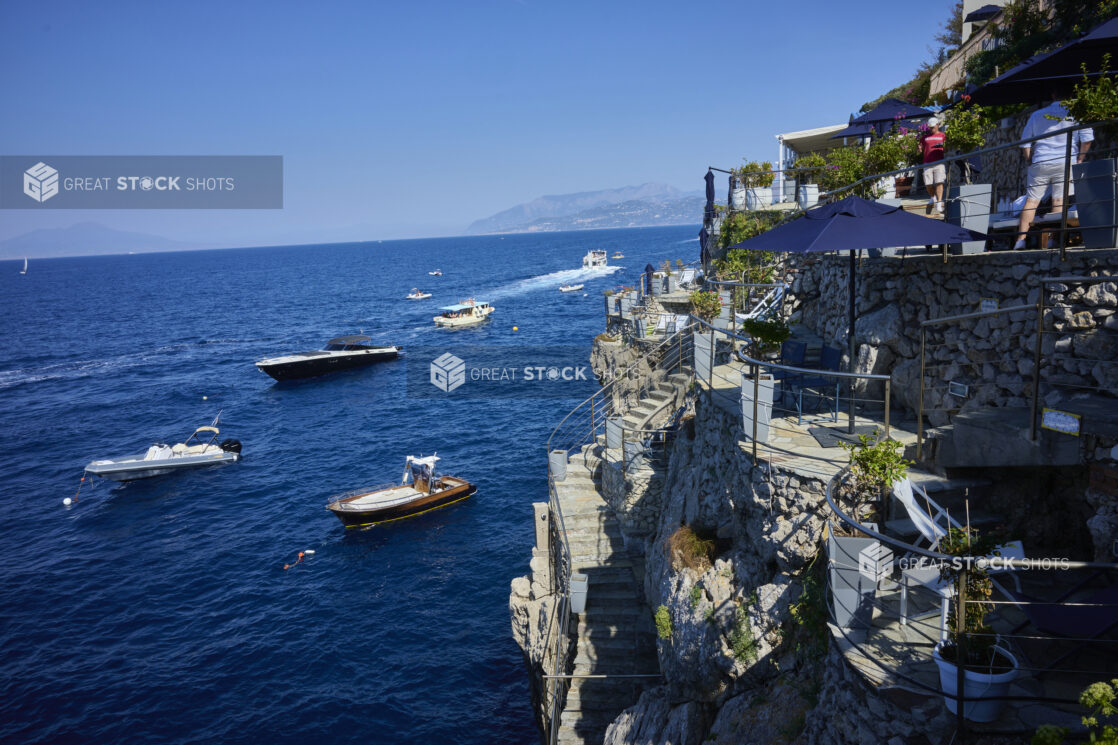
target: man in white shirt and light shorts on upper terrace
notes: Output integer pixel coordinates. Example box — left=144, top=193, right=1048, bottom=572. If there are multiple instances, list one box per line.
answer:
left=1013, top=94, right=1095, bottom=251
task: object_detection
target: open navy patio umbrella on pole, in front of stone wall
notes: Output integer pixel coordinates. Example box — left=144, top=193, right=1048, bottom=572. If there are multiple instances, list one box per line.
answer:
left=730, top=197, right=986, bottom=432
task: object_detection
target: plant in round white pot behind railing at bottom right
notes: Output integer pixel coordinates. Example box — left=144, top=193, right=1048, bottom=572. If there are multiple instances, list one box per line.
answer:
left=932, top=527, right=1017, bottom=722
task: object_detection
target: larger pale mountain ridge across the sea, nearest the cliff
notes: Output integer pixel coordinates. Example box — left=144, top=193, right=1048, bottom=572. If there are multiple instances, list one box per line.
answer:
left=466, top=183, right=699, bottom=235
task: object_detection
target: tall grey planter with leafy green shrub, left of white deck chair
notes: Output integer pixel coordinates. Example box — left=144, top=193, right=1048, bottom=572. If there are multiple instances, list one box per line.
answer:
left=827, top=430, right=910, bottom=631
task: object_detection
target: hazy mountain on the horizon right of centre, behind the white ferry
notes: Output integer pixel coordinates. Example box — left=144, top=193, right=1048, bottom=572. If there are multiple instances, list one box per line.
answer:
left=466, top=183, right=705, bottom=235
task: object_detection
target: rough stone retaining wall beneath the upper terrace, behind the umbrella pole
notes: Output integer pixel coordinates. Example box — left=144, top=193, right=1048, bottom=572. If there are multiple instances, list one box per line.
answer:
left=789, top=249, right=1118, bottom=425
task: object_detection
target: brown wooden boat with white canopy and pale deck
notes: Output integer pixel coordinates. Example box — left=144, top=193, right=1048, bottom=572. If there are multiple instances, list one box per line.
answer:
left=326, top=455, right=477, bottom=528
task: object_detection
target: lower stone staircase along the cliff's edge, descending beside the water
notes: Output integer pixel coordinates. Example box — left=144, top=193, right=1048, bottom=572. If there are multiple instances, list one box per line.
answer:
left=556, top=445, right=660, bottom=745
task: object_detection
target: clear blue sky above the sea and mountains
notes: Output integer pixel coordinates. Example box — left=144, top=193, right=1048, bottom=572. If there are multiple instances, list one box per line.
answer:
left=0, top=0, right=953, bottom=245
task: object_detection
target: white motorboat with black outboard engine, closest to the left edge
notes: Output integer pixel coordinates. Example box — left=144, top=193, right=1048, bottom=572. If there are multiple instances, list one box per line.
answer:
left=85, top=414, right=240, bottom=481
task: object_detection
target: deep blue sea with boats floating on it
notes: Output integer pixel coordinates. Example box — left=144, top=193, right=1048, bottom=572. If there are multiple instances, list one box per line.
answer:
left=0, top=227, right=699, bottom=745
